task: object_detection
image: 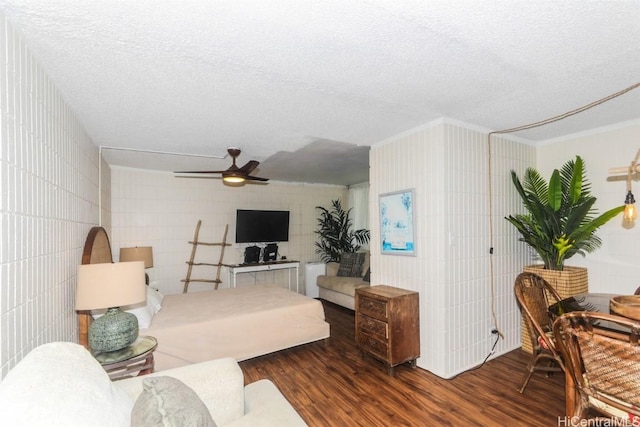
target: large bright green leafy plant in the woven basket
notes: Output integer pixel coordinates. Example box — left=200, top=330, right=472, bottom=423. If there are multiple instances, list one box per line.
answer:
left=505, top=156, right=624, bottom=270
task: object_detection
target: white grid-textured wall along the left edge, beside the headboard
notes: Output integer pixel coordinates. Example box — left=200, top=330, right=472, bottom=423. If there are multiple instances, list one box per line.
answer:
left=0, top=13, right=109, bottom=378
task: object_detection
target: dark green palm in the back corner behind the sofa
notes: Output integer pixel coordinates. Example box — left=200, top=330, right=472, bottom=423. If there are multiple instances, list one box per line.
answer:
left=316, top=200, right=370, bottom=262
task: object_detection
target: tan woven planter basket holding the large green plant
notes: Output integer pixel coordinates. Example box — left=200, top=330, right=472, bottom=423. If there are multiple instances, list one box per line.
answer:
left=522, top=265, right=589, bottom=353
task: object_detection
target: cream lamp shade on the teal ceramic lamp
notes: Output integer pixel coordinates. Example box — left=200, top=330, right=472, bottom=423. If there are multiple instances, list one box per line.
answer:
left=76, top=261, right=147, bottom=310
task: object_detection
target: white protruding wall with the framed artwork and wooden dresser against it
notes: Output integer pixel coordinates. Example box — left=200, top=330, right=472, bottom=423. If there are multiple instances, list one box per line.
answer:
left=370, top=121, right=535, bottom=377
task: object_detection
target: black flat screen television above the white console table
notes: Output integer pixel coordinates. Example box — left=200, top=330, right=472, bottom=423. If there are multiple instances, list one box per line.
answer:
left=236, top=209, right=289, bottom=243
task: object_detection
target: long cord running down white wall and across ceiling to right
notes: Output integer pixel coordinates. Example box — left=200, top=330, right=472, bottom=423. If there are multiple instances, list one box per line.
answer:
left=484, top=82, right=640, bottom=342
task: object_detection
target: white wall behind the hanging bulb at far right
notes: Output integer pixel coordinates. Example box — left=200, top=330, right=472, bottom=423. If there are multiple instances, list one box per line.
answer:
left=537, top=121, right=640, bottom=293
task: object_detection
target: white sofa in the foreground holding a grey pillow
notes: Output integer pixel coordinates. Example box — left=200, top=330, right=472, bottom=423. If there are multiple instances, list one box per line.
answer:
left=0, top=342, right=306, bottom=427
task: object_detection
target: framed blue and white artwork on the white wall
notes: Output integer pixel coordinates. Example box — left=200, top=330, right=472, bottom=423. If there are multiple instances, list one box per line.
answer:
left=380, top=189, right=416, bottom=256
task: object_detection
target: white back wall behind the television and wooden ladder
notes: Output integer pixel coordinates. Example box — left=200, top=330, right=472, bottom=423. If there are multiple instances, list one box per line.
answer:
left=111, top=167, right=347, bottom=294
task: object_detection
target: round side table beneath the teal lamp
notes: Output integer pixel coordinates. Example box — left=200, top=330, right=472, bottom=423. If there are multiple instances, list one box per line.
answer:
left=93, top=335, right=158, bottom=381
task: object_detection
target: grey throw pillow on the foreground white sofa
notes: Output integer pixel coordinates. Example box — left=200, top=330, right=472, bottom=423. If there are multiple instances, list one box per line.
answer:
left=131, top=377, right=216, bottom=427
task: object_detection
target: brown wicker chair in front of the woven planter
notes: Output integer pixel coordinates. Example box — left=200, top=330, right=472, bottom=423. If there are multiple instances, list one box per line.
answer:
left=514, top=272, right=564, bottom=393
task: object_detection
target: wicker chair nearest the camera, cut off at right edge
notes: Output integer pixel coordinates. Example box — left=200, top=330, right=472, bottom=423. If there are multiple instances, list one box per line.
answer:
left=553, top=311, right=640, bottom=425
